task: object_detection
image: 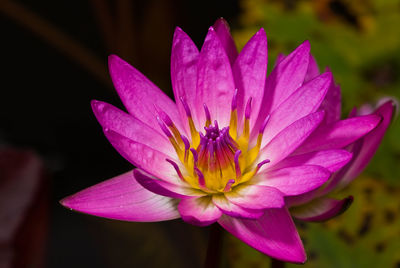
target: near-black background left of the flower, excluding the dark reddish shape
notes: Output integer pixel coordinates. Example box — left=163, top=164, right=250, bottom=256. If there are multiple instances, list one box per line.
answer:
left=0, top=0, right=238, bottom=267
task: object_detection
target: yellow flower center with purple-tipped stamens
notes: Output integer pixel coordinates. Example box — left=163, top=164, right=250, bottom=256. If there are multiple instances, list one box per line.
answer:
left=157, top=91, right=269, bottom=193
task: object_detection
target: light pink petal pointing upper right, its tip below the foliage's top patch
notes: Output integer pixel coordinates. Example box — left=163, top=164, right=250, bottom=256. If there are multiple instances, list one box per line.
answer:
left=260, top=73, right=332, bottom=146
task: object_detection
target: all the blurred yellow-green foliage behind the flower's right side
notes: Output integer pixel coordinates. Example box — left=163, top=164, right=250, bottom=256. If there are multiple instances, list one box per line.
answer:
left=224, top=0, right=400, bottom=267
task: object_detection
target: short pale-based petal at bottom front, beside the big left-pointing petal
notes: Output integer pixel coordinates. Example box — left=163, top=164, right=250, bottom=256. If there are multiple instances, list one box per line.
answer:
left=178, top=196, right=222, bottom=226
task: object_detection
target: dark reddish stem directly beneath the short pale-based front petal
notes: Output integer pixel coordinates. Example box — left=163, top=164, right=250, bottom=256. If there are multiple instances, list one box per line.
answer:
left=204, top=223, right=222, bottom=268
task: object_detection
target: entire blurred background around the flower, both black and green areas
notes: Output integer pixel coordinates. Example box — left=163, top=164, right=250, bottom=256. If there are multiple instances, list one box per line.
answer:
left=0, top=0, right=400, bottom=268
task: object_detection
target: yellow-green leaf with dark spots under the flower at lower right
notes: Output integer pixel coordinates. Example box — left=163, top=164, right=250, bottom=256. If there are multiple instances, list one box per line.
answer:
left=222, top=177, right=400, bottom=268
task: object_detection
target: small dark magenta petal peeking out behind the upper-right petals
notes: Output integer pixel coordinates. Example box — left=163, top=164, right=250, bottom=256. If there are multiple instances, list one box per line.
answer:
left=320, top=68, right=342, bottom=124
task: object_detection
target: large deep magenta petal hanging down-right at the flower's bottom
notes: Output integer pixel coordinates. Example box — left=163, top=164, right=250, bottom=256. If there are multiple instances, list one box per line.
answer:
left=218, top=208, right=307, bottom=263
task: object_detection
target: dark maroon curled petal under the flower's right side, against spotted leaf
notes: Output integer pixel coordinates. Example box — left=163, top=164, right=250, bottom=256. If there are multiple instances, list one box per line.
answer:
left=290, top=196, right=353, bottom=221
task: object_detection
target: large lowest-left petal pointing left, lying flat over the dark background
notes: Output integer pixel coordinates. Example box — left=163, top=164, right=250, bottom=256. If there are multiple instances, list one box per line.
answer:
left=60, top=171, right=179, bottom=222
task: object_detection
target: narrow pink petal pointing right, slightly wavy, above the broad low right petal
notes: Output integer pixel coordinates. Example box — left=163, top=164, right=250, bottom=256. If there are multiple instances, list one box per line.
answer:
left=266, top=150, right=352, bottom=172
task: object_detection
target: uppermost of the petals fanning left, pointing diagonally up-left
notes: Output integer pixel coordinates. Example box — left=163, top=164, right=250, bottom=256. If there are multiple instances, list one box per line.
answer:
left=108, top=55, right=182, bottom=133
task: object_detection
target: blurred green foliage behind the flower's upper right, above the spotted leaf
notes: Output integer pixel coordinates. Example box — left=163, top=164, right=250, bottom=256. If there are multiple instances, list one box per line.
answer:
left=233, top=0, right=400, bottom=185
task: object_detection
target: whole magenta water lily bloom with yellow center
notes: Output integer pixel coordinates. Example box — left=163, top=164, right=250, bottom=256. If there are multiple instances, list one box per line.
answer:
left=61, top=19, right=389, bottom=263
